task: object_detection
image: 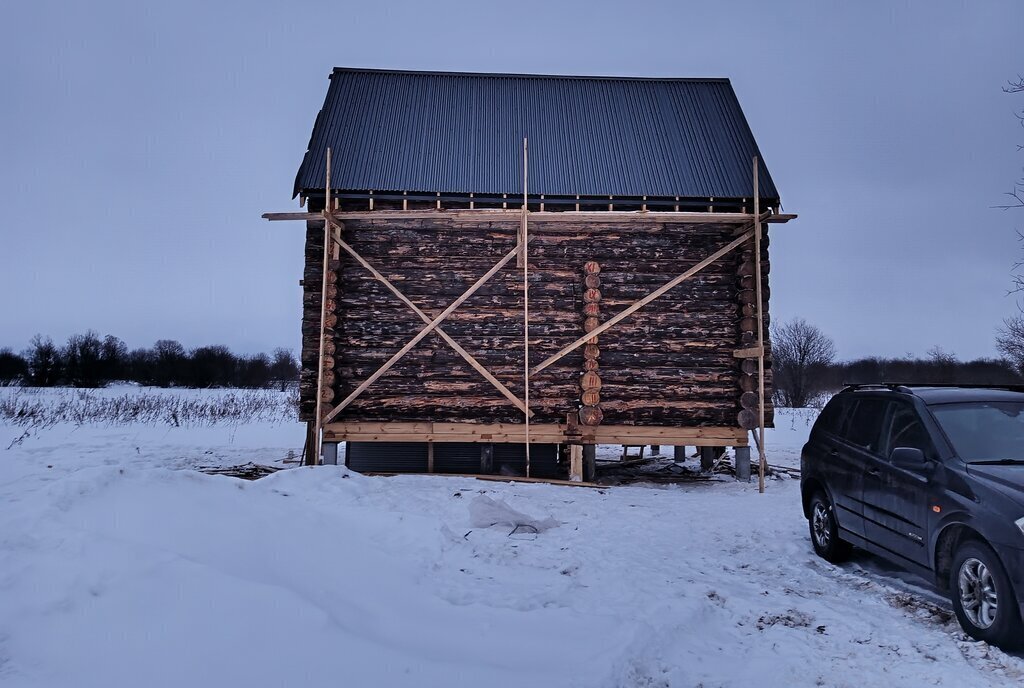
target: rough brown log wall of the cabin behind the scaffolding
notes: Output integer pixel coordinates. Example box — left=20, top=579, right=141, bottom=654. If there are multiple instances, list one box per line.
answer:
left=301, top=214, right=771, bottom=427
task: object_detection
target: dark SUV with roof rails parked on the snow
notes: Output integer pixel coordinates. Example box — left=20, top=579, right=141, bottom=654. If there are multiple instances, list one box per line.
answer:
left=800, top=384, right=1024, bottom=648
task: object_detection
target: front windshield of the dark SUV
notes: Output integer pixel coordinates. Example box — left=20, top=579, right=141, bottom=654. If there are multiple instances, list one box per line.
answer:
left=930, top=401, right=1024, bottom=462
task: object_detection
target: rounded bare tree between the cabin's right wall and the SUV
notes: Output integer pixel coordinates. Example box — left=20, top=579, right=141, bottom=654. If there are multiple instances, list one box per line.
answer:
left=771, top=317, right=836, bottom=407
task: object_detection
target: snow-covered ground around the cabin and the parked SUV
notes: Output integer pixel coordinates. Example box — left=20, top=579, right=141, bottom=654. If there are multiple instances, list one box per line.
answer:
left=0, top=389, right=1024, bottom=688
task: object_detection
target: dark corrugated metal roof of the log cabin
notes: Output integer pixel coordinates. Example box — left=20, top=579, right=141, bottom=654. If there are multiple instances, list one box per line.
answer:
left=295, top=69, right=778, bottom=200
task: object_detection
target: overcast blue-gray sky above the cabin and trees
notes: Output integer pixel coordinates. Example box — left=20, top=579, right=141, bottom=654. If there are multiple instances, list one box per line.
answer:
left=0, top=0, right=1024, bottom=358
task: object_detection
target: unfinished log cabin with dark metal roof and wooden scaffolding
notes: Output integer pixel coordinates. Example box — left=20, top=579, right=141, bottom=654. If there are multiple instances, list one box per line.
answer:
left=264, top=69, right=795, bottom=480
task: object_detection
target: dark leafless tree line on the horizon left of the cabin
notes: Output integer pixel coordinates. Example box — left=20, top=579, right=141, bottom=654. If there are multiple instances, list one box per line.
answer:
left=0, top=330, right=299, bottom=389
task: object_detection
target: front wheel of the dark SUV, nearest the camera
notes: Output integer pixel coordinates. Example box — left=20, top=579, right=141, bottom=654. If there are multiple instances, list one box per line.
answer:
left=949, top=541, right=1024, bottom=648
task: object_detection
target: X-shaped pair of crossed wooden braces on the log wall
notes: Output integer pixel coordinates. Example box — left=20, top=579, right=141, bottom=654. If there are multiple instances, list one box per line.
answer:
left=323, top=212, right=532, bottom=423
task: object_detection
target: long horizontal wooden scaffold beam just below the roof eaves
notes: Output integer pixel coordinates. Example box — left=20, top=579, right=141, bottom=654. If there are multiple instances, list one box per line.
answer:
left=261, top=208, right=797, bottom=224
